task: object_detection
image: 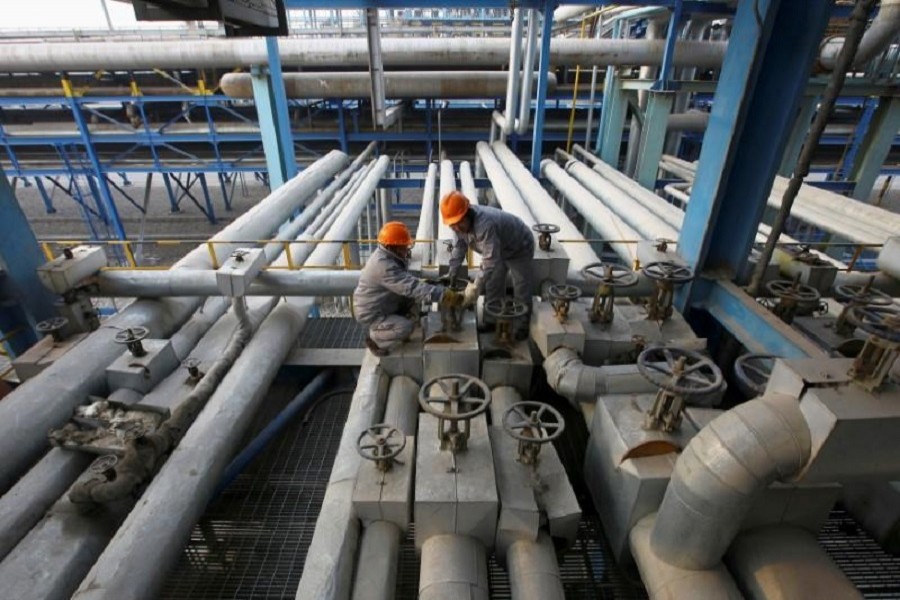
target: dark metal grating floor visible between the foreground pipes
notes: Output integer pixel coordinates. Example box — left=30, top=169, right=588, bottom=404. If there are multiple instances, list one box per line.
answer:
left=161, top=318, right=900, bottom=600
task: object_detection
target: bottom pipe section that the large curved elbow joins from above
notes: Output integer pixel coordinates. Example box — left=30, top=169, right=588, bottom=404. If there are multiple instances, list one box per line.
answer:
left=628, top=513, right=744, bottom=600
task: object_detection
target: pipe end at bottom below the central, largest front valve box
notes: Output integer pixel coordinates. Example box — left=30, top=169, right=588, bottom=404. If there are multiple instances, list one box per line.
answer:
left=419, top=534, right=490, bottom=600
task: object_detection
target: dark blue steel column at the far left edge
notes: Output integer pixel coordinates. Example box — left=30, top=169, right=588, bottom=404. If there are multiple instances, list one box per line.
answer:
left=0, top=170, right=56, bottom=355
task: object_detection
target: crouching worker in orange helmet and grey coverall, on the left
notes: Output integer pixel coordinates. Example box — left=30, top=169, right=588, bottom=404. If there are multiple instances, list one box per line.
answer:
left=353, top=221, right=463, bottom=356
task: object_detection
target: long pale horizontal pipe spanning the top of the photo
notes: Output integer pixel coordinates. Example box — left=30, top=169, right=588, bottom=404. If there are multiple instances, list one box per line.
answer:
left=0, top=37, right=727, bottom=73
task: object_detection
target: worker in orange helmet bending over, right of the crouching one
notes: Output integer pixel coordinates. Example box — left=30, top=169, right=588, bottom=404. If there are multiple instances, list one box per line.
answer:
left=441, top=190, right=534, bottom=340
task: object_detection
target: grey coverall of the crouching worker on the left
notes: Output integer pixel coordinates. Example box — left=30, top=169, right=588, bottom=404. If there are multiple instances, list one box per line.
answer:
left=353, top=246, right=444, bottom=350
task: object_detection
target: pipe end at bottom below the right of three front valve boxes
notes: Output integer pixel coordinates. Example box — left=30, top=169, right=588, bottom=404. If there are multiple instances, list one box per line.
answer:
left=506, top=531, right=566, bottom=600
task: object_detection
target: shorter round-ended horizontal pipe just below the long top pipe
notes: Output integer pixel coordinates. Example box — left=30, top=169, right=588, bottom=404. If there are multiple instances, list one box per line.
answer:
left=219, top=71, right=557, bottom=99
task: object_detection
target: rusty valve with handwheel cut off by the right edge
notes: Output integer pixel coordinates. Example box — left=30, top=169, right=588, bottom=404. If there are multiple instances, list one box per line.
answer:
left=847, top=306, right=900, bottom=392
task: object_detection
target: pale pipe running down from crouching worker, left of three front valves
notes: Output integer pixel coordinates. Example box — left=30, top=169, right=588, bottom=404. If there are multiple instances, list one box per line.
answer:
left=296, top=352, right=388, bottom=600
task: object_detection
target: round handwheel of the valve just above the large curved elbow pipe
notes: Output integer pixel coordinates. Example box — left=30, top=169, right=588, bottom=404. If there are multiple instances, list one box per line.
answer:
left=637, top=346, right=724, bottom=396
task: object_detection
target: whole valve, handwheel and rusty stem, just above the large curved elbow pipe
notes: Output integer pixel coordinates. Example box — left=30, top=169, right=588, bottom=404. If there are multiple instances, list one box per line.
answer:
left=637, top=346, right=724, bottom=432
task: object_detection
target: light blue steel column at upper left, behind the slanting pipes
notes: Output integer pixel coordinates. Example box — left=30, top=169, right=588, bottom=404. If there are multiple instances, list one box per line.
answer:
left=250, top=37, right=297, bottom=190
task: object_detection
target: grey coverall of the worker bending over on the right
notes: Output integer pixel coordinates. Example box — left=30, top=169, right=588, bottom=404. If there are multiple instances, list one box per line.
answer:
left=449, top=205, right=534, bottom=329
